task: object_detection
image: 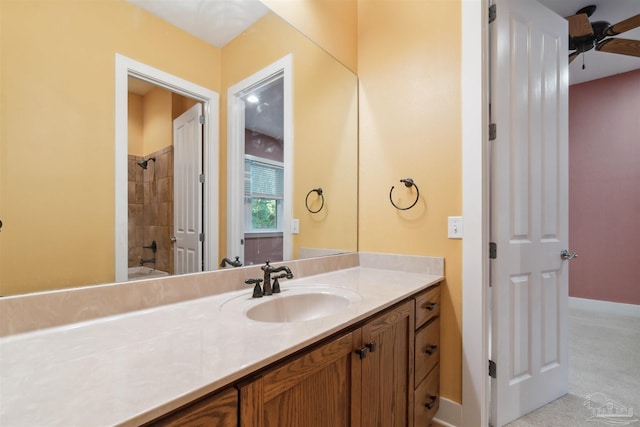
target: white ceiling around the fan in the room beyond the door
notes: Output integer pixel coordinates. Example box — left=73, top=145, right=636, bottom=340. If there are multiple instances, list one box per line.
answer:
left=536, top=0, right=640, bottom=84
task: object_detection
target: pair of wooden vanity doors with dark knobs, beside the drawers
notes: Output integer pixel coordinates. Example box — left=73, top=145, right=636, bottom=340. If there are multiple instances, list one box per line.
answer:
left=239, top=300, right=414, bottom=427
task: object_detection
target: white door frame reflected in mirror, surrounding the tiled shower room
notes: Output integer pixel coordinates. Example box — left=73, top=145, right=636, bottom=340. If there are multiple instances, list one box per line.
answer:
left=115, top=54, right=219, bottom=282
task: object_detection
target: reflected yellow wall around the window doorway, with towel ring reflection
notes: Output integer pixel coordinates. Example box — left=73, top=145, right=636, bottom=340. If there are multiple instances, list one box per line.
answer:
left=220, top=13, right=358, bottom=258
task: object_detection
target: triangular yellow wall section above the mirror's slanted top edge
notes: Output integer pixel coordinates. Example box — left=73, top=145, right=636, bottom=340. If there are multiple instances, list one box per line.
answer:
left=262, top=0, right=358, bottom=73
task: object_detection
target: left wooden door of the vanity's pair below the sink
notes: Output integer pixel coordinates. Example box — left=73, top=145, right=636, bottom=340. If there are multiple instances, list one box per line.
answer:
left=239, top=333, right=359, bottom=427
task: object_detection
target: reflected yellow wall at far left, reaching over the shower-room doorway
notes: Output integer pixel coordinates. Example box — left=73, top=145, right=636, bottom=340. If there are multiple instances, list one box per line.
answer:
left=0, top=0, right=220, bottom=295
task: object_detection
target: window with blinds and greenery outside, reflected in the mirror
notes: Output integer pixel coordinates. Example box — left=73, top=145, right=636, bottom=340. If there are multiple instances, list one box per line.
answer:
left=244, top=155, right=284, bottom=233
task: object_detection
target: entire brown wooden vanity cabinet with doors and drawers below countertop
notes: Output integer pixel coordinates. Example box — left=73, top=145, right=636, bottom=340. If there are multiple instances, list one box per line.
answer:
left=147, top=285, right=440, bottom=427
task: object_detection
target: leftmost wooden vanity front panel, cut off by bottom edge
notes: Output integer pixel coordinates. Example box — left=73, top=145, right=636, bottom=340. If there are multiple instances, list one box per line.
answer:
left=148, top=387, right=238, bottom=427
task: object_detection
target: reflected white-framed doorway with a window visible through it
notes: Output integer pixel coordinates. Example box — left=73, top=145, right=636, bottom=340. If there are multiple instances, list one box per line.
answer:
left=228, top=57, right=293, bottom=265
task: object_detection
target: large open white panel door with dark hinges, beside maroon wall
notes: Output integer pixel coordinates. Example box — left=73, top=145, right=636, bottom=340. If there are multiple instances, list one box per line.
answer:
left=490, top=0, right=568, bottom=426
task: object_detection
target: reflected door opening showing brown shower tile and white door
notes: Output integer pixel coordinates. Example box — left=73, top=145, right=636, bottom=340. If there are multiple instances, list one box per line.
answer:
left=127, top=76, right=203, bottom=280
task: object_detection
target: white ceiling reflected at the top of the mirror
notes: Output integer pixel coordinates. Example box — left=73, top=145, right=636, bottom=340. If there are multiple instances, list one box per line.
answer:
left=128, top=0, right=269, bottom=47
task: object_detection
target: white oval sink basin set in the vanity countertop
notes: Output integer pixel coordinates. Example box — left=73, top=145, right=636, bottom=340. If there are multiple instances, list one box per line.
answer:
left=220, top=285, right=361, bottom=323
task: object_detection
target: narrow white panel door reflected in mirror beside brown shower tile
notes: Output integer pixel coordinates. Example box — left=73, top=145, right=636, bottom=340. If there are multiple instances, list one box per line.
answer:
left=173, top=103, right=202, bottom=274
